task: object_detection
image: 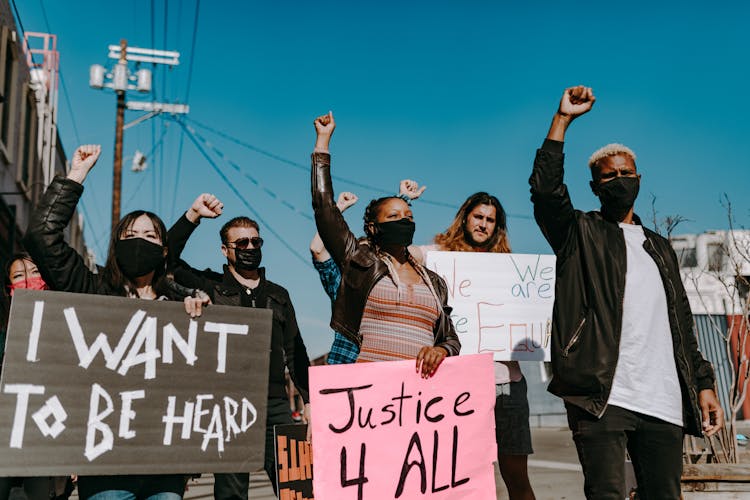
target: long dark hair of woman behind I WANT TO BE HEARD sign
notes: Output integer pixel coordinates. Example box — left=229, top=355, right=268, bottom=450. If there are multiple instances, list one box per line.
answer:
left=102, top=210, right=169, bottom=295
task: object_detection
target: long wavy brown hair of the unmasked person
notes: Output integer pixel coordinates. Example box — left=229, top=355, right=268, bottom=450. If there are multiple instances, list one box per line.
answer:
left=434, top=191, right=510, bottom=253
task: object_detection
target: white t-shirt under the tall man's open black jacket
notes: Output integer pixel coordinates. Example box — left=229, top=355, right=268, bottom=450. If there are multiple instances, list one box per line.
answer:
left=607, top=223, right=683, bottom=426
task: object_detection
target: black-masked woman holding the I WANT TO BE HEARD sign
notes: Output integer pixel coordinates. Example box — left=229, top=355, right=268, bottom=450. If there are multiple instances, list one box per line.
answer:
left=24, top=145, right=203, bottom=500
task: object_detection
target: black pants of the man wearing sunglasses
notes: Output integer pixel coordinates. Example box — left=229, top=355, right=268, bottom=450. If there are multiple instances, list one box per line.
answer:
left=214, top=398, right=294, bottom=500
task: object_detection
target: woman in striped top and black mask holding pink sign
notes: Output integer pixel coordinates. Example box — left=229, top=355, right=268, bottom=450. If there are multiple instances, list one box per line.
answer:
left=312, top=112, right=461, bottom=378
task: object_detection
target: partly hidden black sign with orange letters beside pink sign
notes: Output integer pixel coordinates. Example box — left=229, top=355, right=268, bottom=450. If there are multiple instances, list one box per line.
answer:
left=273, top=424, right=314, bottom=500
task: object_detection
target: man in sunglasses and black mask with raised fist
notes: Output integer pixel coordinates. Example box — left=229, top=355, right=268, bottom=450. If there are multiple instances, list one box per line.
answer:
left=168, top=194, right=310, bottom=500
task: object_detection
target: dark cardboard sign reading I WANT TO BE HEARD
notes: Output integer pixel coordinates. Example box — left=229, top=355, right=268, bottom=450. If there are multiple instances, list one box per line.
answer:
left=0, top=290, right=272, bottom=476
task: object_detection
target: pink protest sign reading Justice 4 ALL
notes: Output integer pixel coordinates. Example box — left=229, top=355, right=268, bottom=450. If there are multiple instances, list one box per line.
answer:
left=310, top=354, right=497, bottom=500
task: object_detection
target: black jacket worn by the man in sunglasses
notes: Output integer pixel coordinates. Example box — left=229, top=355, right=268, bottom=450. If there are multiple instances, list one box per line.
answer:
left=167, top=215, right=310, bottom=403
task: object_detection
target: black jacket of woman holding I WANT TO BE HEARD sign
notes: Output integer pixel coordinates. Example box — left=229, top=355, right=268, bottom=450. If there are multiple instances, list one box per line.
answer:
left=24, top=177, right=185, bottom=498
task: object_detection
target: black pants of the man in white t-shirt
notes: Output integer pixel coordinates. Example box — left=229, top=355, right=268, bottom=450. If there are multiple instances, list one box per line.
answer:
left=565, top=403, right=683, bottom=500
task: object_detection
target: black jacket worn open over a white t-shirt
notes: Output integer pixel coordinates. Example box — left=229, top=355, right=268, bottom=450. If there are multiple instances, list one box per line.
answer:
left=529, top=140, right=714, bottom=436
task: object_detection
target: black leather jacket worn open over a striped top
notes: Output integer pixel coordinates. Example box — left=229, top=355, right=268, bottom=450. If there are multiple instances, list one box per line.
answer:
left=312, top=153, right=461, bottom=356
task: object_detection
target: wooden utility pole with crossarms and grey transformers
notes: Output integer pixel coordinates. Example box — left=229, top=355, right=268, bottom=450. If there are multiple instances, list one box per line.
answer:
left=89, top=40, right=190, bottom=231
